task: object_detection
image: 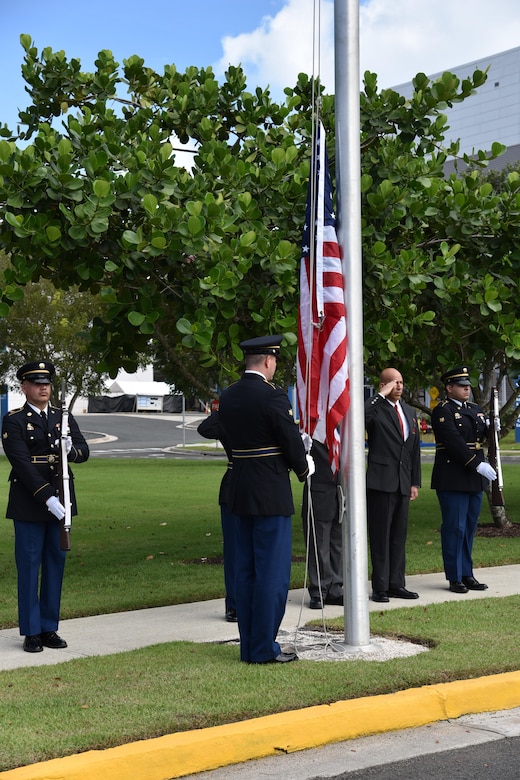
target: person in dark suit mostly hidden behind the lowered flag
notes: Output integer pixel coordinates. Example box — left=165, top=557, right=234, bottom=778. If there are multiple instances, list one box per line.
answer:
left=302, top=441, right=343, bottom=609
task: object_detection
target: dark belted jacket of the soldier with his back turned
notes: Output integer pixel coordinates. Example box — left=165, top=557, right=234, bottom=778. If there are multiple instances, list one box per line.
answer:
left=219, top=372, right=309, bottom=516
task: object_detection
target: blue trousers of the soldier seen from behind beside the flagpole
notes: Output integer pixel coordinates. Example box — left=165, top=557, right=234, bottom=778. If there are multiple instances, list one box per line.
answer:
left=235, top=515, right=292, bottom=663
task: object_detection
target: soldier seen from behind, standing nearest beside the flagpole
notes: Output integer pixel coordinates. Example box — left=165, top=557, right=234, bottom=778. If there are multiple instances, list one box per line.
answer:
left=219, top=336, right=312, bottom=664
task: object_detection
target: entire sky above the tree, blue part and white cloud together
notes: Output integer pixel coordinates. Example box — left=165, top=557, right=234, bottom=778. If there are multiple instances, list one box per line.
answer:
left=0, top=0, right=520, bottom=128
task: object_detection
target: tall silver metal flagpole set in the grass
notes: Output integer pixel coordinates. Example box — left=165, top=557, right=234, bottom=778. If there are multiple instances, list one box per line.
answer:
left=334, top=0, right=375, bottom=650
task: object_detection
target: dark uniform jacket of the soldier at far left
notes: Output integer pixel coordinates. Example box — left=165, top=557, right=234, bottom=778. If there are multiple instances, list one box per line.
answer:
left=2, top=404, right=89, bottom=523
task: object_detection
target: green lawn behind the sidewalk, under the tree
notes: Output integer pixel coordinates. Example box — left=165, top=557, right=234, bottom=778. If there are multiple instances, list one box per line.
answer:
left=0, top=458, right=520, bottom=628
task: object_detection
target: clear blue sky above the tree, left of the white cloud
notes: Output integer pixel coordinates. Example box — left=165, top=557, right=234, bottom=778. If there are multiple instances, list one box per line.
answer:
left=0, top=0, right=284, bottom=129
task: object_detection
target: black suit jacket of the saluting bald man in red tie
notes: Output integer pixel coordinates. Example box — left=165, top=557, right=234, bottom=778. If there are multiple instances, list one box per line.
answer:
left=365, top=393, right=421, bottom=496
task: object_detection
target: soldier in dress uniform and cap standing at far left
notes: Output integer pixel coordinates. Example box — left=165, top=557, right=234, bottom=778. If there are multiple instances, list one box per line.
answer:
left=2, top=360, right=89, bottom=653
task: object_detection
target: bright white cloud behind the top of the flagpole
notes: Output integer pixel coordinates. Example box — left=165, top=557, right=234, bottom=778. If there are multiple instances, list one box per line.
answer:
left=215, top=0, right=520, bottom=95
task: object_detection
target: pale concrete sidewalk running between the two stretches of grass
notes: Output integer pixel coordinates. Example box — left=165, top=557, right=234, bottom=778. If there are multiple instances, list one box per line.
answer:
left=0, top=565, right=520, bottom=671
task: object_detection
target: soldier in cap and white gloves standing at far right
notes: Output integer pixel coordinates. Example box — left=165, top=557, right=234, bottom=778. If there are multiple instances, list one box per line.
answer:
left=431, top=366, right=497, bottom=593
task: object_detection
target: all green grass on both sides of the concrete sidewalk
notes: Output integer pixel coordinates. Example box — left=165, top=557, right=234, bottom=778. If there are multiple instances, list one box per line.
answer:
left=0, top=458, right=520, bottom=770
